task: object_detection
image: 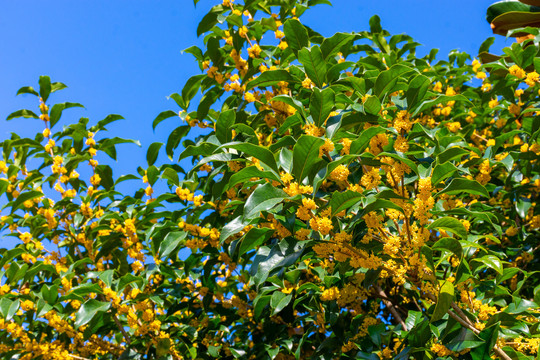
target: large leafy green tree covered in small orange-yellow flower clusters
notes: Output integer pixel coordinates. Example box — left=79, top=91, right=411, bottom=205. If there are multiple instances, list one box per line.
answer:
left=0, top=0, right=540, bottom=359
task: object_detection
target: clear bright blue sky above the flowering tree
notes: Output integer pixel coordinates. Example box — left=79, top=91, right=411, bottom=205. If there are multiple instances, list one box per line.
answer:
left=0, top=0, right=513, bottom=180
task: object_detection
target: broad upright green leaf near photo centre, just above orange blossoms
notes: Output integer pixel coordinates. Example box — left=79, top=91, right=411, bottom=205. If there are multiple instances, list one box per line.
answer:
left=292, top=135, right=324, bottom=182
